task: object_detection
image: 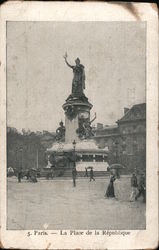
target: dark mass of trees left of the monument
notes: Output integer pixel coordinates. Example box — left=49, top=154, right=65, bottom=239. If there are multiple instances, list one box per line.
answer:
left=7, top=128, right=46, bottom=172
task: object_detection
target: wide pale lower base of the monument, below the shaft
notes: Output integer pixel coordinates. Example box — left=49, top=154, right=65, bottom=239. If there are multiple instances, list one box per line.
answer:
left=47, top=139, right=108, bottom=175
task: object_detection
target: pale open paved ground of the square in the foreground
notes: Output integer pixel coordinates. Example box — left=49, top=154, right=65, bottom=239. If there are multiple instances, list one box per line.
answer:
left=7, top=177, right=146, bottom=230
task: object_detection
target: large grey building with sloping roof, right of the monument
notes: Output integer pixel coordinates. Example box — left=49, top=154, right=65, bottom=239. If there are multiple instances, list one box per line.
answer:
left=94, top=103, right=146, bottom=171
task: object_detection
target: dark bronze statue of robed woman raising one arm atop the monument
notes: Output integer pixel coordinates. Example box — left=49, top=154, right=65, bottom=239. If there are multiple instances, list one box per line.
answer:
left=64, top=53, right=85, bottom=97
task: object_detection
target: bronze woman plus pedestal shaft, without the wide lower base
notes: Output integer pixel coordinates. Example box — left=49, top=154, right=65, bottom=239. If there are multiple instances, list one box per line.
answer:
left=63, top=54, right=93, bottom=143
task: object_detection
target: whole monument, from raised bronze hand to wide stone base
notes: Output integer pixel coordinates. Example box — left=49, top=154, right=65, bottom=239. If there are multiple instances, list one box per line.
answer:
left=47, top=53, right=108, bottom=177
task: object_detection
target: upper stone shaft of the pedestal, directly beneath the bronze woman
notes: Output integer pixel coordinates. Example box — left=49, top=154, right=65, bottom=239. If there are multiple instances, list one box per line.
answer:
left=63, top=97, right=92, bottom=143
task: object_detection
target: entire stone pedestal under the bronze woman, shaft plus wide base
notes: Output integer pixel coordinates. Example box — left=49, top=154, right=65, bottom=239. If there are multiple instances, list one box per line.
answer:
left=47, top=95, right=108, bottom=178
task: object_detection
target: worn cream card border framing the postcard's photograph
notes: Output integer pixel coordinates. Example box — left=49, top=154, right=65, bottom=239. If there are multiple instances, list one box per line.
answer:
left=0, top=1, right=158, bottom=249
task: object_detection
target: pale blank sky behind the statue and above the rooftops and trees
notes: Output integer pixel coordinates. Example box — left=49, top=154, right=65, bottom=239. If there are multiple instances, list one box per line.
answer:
left=7, top=21, right=146, bottom=132
